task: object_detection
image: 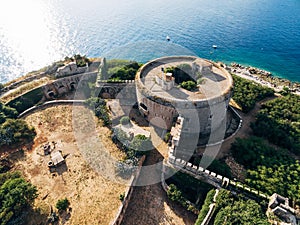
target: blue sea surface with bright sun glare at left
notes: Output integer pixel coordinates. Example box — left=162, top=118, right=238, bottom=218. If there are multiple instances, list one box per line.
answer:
left=0, top=0, right=300, bottom=82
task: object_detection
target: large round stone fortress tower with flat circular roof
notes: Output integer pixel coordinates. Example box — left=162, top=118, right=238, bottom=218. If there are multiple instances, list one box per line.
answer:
left=136, top=56, right=233, bottom=147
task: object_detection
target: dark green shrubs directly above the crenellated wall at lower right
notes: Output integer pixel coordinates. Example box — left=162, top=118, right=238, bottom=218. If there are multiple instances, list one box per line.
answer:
left=231, top=137, right=300, bottom=204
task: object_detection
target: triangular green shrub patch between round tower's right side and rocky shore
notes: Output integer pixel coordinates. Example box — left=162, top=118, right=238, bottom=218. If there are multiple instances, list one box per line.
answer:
left=232, top=75, right=274, bottom=113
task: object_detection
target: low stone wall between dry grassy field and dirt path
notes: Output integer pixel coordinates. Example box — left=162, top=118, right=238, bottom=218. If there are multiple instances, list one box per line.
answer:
left=110, top=155, right=146, bottom=225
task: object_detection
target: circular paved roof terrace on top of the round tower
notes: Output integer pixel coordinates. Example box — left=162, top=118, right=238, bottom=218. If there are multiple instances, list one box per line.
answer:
left=141, top=57, right=232, bottom=100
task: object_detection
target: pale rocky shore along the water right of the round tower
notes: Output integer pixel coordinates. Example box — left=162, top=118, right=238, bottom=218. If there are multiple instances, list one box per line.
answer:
left=223, top=63, right=300, bottom=95
